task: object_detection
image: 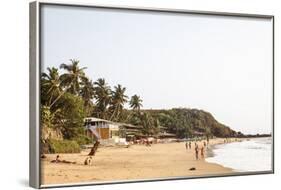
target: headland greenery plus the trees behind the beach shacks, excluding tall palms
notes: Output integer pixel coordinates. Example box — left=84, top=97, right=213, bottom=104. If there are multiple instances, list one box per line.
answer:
left=123, top=108, right=236, bottom=138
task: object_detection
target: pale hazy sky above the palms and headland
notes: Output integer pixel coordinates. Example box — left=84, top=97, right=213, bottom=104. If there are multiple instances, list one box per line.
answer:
left=42, top=5, right=272, bottom=133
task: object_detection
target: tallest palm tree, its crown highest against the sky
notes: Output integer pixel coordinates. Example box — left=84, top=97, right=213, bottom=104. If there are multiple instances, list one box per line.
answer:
left=60, top=59, right=86, bottom=95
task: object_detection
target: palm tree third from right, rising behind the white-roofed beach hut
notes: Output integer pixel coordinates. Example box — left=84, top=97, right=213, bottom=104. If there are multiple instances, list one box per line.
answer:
left=94, top=78, right=111, bottom=119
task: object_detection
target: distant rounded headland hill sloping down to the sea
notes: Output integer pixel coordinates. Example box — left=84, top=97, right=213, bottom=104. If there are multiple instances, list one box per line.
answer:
left=142, top=108, right=237, bottom=138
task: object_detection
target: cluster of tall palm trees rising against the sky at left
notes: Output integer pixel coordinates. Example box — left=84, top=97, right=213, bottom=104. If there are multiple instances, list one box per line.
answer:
left=41, top=59, right=142, bottom=121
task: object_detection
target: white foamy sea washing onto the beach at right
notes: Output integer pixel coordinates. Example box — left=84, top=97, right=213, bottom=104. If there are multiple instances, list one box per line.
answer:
left=206, top=137, right=273, bottom=172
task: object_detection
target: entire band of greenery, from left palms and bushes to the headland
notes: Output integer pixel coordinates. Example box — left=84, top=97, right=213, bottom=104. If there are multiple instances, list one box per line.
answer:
left=41, top=59, right=238, bottom=153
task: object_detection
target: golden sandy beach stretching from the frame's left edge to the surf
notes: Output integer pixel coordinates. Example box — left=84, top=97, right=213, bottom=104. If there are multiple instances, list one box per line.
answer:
left=41, top=139, right=234, bottom=185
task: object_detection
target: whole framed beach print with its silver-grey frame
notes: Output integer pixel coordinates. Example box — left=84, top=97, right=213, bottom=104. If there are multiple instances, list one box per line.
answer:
left=30, top=1, right=274, bottom=188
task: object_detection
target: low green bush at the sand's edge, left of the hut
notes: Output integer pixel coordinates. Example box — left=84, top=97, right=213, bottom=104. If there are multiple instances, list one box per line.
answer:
left=47, top=140, right=81, bottom=153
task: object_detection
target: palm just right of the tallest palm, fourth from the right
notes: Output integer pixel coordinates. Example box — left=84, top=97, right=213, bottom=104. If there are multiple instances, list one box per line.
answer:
left=80, top=77, right=95, bottom=115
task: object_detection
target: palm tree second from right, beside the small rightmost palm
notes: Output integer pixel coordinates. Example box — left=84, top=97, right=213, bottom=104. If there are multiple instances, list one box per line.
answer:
left=109, top=84, right=128, bottom=120
